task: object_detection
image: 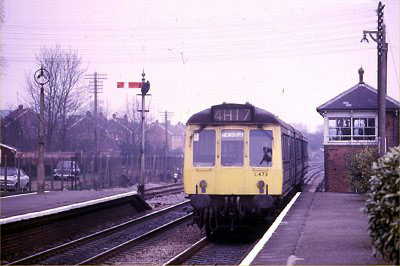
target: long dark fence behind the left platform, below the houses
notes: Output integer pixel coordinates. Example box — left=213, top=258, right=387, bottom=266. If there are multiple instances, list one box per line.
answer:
left=0, top=155, right=183, bottom=193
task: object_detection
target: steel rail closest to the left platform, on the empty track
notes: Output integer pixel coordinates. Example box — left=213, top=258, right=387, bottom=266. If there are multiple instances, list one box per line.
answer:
left=7, top=200, right=190, bottom=265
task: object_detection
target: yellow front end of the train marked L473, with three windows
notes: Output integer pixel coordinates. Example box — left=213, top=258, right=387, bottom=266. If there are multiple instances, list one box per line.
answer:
left=184, top=125, right=283, bottom=195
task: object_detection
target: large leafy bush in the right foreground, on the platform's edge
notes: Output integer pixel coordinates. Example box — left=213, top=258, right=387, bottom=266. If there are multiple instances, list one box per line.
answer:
left=364, top=146, right=400, bottom=265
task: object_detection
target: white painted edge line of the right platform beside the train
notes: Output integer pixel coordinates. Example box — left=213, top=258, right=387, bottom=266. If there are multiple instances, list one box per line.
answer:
left=239, top=192, right=301, bottom=266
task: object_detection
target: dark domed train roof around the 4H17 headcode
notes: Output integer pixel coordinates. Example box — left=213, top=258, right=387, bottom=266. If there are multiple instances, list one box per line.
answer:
left=186, top=103, right=303, bottom=137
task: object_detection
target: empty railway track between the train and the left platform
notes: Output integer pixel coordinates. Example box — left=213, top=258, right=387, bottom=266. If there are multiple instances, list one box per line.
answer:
left=9, top=201, right=191, bottom=265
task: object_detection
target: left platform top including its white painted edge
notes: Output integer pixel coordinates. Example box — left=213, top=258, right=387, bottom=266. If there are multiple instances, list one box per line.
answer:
left=0, top=187, right=136, bottom=221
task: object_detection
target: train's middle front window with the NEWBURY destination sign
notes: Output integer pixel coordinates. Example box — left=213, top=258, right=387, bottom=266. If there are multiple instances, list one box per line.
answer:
left=221, top=129, right=244, bottom=166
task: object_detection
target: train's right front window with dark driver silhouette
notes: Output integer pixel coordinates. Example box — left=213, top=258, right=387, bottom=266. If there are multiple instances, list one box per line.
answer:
left=250, top=129, right=273, bottom=167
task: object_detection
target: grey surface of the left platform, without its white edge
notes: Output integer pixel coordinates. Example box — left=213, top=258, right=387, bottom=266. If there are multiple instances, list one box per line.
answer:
left=0, top=187, right=136, bottom=219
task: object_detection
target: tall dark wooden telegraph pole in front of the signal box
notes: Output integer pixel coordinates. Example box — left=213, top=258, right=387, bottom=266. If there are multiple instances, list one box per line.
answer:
left=361, top=2, right=388, bottom=156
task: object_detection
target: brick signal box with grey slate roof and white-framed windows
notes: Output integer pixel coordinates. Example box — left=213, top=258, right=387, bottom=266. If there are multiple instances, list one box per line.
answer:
left=317, top=68, right=400, bottom=192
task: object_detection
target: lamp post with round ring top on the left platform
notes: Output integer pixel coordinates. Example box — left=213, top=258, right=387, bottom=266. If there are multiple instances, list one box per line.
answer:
left=34, top=66, right=50, bottom=194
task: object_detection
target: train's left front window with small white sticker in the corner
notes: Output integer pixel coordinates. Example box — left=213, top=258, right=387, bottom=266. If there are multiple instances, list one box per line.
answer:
left=193, top=129, right=215, bottom=167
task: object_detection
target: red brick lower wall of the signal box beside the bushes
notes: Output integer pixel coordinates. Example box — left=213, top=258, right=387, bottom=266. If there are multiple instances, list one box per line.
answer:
left=324, top=145, right=376, bottom=193
